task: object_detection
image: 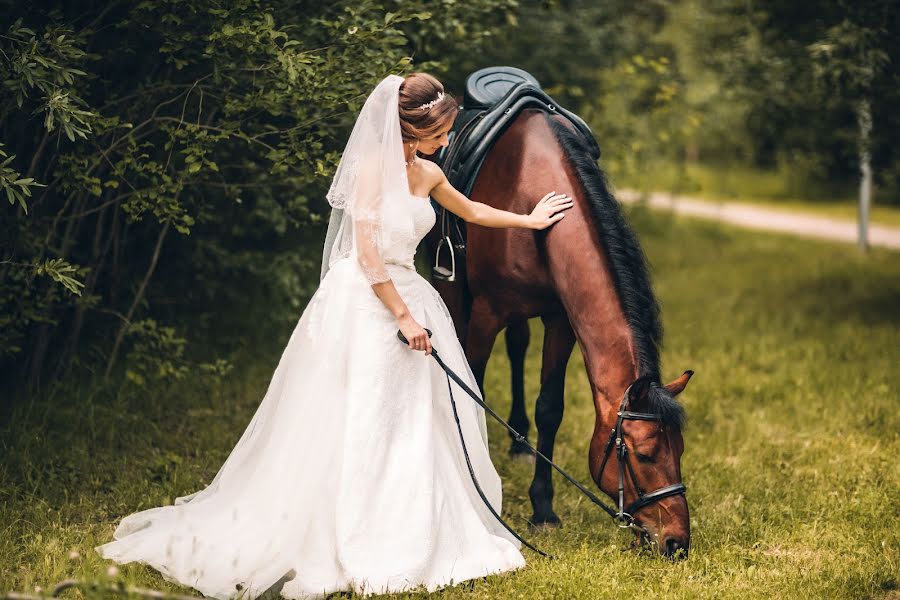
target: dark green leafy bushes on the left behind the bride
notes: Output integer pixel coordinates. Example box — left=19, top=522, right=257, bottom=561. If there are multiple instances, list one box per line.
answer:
left=0, top=0, right=515, bottom=392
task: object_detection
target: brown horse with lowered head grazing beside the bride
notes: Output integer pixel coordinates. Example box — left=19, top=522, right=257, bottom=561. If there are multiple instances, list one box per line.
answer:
left=426, top=109, right=692, bottom=555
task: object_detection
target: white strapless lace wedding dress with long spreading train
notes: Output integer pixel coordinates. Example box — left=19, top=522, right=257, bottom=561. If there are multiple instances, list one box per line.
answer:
left=96, top=195, right=525, bottom=600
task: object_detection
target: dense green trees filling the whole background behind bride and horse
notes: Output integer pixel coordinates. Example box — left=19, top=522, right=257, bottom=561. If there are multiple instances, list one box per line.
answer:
left=0, top=0, right=900, bottom=399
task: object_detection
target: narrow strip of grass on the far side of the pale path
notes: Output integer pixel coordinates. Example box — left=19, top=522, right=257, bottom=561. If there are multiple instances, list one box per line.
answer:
left=620, top=164, right=900, bottom=227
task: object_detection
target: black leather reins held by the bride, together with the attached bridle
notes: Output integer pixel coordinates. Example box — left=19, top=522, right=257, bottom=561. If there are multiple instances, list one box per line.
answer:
left=397, top=328, right=687, bottom=558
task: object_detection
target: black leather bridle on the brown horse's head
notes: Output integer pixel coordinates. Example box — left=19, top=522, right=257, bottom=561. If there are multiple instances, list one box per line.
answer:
left=597, top=383, right=687, bottom=534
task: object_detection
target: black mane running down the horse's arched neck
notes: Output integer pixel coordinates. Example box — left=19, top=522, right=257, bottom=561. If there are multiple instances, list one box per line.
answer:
left=544, top=113, right=664, bottom=380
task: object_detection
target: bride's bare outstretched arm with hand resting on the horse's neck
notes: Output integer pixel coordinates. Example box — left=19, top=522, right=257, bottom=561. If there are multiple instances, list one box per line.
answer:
left=430, top=163, right=572, bottom=229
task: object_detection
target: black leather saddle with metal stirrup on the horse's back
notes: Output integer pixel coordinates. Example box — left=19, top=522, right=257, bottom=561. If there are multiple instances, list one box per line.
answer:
left=432, top=67, right=600, bottom=281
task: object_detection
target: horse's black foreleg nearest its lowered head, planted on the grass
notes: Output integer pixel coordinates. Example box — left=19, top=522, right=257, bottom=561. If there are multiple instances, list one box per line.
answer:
left=528, top=314, right=575, bottom=526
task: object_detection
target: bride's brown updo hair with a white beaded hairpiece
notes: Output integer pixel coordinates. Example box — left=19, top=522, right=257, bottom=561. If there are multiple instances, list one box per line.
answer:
left=398, top=73, right=459, bottom=144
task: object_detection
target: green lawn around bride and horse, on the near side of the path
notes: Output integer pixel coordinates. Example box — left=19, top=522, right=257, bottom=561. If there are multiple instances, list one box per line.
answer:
left=0, top=210, right=900, bottom=599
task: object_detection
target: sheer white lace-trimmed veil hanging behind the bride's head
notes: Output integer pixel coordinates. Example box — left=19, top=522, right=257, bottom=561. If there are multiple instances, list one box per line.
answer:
left=319, top=75, right=409, bottom=284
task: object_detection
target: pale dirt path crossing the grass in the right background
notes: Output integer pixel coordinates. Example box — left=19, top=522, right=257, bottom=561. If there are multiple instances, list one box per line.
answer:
left=616, top=190, right=900, bottom=250
